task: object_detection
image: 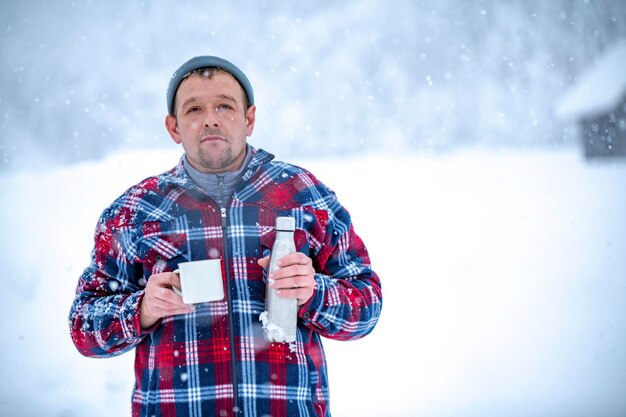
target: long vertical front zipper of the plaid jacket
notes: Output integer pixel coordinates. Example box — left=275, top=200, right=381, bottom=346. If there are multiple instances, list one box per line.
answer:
left=218, top=177, right=241, bottom=415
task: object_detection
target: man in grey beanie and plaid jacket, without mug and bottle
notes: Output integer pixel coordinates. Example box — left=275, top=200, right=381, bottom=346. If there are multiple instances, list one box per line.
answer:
left=69, top=56, right=382, bottom=417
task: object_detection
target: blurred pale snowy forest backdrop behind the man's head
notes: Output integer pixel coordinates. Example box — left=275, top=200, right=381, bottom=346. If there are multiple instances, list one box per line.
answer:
left=0, top=0, right=626, bottom=171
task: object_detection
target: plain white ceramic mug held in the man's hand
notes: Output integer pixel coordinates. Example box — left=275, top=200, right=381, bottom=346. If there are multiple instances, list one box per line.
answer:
left=172, top=259, right=224, bottom=304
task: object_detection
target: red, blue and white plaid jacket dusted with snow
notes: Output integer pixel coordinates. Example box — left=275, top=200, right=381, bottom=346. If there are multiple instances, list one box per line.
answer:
left=69, top=148, right=382, bottom=417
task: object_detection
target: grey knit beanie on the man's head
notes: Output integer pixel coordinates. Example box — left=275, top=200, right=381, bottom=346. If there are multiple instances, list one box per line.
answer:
left=167, top=56, right=254, bottom=115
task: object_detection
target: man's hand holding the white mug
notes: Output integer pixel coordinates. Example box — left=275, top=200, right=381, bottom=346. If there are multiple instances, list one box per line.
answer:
left=139, top=272, right=194, bottom=329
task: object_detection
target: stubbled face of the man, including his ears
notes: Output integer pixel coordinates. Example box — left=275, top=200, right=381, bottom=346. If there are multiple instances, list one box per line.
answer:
left=165, top=71, right=256, bottom=173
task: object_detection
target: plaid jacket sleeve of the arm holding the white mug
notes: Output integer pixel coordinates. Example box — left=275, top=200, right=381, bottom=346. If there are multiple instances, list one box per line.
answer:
left=69, top=209, right=145, bottom=357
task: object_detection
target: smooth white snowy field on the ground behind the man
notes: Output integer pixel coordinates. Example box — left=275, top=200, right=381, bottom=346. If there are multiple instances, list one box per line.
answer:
left=0, top=149, right=626, bottom=417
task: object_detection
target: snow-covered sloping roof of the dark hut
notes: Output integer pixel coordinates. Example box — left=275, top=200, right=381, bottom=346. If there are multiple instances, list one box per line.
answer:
left=556, top=40, right=626, bottom=119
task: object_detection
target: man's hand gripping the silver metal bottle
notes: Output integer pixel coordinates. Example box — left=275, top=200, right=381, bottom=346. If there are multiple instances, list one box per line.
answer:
left=259, top=252, right=315, bottom=306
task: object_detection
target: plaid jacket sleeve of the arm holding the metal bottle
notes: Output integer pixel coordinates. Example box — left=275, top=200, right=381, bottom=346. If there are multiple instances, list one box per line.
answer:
left=298, top=193, right=382, bottom=340
